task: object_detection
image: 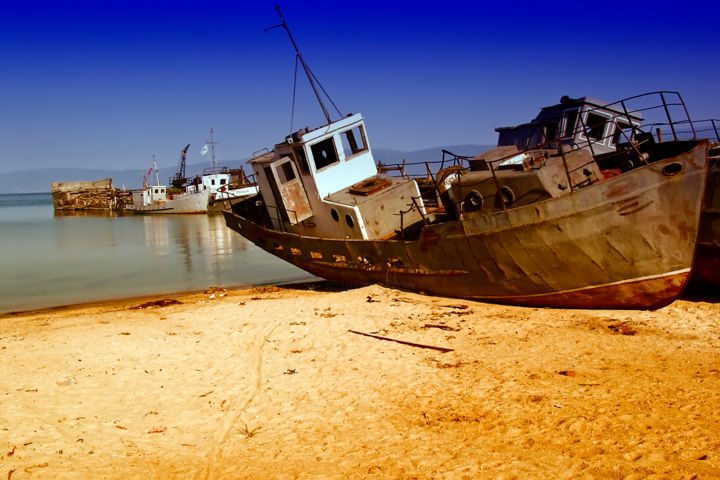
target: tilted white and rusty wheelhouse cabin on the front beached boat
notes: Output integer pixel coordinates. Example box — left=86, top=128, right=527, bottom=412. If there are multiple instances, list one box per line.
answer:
left=250, top=114, right=424, bottom=239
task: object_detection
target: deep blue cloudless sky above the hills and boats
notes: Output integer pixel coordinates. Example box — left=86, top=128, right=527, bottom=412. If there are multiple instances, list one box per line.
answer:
left=0, top=0, right=720, bottom=174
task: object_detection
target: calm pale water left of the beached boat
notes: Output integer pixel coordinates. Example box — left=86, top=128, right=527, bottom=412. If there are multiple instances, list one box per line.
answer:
left=0, top=193, right=314, bottom=313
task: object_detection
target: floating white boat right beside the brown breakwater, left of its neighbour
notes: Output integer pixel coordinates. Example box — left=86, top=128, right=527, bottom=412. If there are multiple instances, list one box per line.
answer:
left=126, top=156, right=210, bottom=214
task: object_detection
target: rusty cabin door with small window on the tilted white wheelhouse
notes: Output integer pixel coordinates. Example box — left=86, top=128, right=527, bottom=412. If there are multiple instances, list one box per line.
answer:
left=266, top=157, right=313, bottom=225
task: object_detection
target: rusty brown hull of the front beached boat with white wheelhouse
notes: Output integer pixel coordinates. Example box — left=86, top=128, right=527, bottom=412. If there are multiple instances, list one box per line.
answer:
left=223, top=140, right=708, bottom=309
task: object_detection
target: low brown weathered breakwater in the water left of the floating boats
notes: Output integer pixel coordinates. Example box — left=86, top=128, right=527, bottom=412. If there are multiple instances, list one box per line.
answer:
left=51, top=178, right=132, bottom=211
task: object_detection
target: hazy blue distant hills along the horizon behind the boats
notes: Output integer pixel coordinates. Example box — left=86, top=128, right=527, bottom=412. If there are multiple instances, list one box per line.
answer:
left=0, top=145, right=494, bottom=193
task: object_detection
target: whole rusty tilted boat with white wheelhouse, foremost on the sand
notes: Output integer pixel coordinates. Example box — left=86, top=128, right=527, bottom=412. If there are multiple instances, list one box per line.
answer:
left=223, top=12, right=708, bottom=308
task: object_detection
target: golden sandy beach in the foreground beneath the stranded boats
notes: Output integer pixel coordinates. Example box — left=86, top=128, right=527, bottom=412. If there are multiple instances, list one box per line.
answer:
left=0, top=284, right=720, bottom=480
